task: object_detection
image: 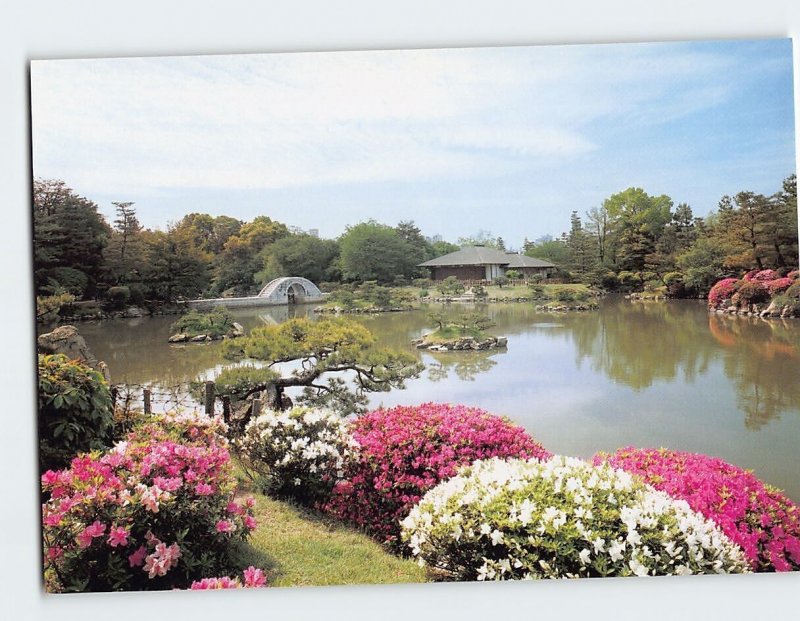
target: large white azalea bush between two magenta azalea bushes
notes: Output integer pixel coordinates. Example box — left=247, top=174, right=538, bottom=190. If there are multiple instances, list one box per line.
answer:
left=401, top=456, right=749, bottom=580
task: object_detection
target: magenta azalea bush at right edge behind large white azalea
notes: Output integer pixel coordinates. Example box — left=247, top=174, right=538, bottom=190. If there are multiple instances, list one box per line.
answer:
left=594, top=448, right=800, bottom=571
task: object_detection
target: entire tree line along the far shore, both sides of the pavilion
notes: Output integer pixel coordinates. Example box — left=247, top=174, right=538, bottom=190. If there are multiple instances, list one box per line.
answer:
left=33, top=175, right=798, bottom=306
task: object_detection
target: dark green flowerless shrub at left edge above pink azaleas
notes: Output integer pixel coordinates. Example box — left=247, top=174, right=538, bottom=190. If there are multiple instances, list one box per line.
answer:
left=38, top=354, right=114, bottom=472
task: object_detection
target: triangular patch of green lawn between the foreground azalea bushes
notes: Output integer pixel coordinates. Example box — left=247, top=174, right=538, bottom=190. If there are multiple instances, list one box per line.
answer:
left=228, top=486, right=427, bottom=586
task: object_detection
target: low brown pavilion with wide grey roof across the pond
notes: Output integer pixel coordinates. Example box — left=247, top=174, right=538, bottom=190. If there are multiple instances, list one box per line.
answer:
left=419, top=246, right=556, bottom=280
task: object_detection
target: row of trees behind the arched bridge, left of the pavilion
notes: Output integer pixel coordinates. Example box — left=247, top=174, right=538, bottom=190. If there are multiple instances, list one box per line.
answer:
left=33, top=179, right=459, bottom=305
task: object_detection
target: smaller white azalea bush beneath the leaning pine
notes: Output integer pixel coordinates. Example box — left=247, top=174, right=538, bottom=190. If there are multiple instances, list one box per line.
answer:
left=236, top=407, right=356, bottom=503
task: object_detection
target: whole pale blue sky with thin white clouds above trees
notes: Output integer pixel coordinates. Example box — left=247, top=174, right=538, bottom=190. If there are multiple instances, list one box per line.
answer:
left=31, top=39, right=796, bottom=248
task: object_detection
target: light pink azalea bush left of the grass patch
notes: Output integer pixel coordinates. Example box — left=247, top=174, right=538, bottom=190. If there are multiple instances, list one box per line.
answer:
left=42, top=414, right=256, bottom=591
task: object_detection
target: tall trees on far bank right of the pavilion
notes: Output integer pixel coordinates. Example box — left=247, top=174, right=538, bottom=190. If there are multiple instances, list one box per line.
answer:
left=525, top=175, right=798, bottom=296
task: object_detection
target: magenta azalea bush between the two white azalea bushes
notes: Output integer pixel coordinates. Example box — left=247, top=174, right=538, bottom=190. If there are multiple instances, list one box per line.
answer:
left=326, top=403, right=550, bottom=543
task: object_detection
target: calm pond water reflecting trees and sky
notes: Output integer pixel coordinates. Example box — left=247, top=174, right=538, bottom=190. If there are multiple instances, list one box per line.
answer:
left=72, top=298, right=800, bottom=501
